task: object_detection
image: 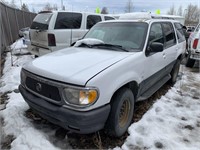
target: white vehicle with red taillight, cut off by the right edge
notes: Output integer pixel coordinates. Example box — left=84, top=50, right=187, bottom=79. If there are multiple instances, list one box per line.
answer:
left=186, top=24, right=200, bottom=67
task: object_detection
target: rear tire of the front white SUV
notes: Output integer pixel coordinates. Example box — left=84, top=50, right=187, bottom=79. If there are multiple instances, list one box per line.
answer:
left=169, top=59, right=181, bottom=85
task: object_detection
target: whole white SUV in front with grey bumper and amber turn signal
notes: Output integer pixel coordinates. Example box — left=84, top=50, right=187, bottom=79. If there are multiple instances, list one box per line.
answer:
left=19, top=19, right=186, bottom=137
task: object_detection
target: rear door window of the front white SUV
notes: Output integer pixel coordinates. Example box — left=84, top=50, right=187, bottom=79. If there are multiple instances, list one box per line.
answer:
left=162, top=22, right=176, bottom=48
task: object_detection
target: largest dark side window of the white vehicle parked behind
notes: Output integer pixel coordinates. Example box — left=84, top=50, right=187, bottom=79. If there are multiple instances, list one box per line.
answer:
left=55, top=12, right=82, bottom=29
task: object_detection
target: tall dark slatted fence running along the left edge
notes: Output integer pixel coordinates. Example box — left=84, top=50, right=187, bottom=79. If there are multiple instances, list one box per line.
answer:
left=0, top=2, right=36, bottom=54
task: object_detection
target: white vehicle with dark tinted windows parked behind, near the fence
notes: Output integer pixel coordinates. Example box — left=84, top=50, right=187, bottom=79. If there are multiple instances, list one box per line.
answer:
left=28, top=11, right=114, bottom=56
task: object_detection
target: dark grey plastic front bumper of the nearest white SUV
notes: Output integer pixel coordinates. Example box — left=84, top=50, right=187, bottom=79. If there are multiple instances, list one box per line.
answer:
left=19, top=85, right=110, bottom=134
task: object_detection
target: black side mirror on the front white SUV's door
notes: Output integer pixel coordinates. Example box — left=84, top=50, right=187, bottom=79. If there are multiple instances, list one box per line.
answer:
left=146, top=42, right=164, bottom=55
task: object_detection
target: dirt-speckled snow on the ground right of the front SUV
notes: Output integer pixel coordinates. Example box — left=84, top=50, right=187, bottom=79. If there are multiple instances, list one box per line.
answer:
left=122, top=66, right=200, bottom=150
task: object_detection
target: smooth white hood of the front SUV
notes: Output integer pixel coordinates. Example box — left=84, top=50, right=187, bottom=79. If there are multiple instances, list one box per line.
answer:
left=24, top=47, right=133, bottom=85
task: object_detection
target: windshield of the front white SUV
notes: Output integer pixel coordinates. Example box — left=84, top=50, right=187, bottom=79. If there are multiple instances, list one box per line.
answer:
left=84, top=22, right=148, bottom=51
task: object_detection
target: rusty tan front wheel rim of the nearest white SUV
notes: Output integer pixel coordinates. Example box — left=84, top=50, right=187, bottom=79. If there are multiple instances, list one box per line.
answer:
left=119, top=100, right=130, bottom=127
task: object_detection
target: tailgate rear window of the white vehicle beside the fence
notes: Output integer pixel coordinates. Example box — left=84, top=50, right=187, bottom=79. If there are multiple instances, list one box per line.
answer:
left=31, top=13, right=52, bottom=30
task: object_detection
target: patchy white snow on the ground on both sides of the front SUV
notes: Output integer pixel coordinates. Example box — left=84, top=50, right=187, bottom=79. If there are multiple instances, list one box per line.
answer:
left=0, top=40, right=200, bottom=150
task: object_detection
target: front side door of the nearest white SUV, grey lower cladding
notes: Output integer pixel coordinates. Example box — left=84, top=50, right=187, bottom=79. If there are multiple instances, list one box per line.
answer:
left=140, top=22, right=167, bottom=94
